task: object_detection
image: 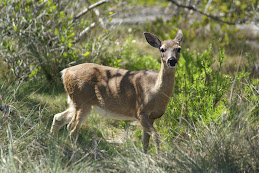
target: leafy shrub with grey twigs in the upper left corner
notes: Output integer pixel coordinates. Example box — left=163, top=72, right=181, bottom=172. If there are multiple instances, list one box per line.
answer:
left=0, top=0, right=114, bottom=83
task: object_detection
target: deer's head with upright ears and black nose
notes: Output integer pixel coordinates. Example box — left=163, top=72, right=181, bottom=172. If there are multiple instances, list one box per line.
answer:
left=144, top=30, right=183, bottom=68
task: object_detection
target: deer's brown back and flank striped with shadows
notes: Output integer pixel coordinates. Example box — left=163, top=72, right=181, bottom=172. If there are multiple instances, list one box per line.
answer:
left=63, top=63, right=157, bottom=116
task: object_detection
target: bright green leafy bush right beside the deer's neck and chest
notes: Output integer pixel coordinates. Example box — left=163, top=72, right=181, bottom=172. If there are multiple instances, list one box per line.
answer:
left=158, top=45, right=258, bottom=140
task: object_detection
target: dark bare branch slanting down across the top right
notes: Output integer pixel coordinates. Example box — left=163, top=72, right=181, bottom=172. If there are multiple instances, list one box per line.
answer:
left=170, top=0, right=246, bottom=25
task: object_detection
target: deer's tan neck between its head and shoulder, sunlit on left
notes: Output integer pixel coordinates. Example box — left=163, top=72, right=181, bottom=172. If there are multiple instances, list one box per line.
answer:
left=154, top=63, right=175, bottom=98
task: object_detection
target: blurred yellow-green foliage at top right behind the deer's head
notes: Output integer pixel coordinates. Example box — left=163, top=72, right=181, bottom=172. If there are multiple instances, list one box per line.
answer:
left=144, top=0, right=259, bottom=59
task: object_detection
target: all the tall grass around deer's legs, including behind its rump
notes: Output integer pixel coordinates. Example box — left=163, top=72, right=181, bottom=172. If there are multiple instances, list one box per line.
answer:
left=0, top=60, right=259, bottom=172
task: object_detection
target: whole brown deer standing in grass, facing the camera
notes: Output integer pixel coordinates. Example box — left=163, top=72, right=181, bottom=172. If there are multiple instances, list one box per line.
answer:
left=51, top=29, right=183, bottom=153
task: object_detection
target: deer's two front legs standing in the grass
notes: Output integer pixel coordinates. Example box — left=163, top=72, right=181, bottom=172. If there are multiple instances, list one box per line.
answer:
left=140, top=114, right=159, bottom=154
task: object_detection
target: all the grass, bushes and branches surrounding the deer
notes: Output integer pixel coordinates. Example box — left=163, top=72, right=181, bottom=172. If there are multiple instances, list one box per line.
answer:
left=0, top=0, right=259, bottom=172
